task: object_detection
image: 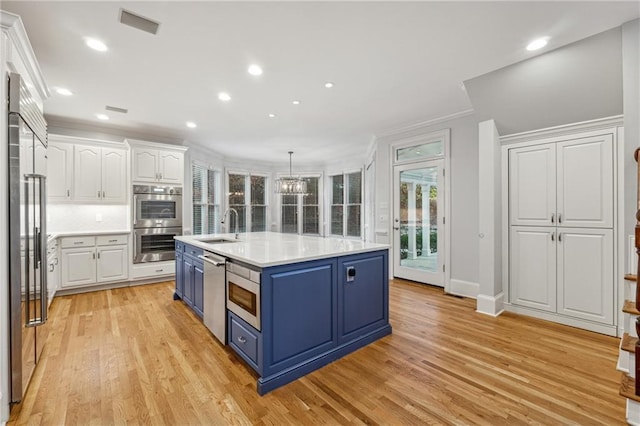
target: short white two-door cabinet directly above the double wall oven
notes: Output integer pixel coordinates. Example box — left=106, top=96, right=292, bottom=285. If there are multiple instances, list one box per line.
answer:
left=132, top=147, right=184, bottom=185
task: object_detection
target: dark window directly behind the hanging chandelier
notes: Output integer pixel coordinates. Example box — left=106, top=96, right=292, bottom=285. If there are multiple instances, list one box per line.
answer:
left=280, top=176, right=320, bottom=235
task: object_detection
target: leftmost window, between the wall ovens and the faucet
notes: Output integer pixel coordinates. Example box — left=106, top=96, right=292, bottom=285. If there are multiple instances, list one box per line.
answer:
left=191, top=163, right=220, bottom=235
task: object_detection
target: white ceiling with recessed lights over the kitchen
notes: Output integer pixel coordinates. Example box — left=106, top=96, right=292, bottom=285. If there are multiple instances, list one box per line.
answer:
left=1, top=1, right=640, bottom=163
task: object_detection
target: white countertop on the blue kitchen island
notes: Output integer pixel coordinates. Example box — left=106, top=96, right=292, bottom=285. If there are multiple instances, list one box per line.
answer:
left=174, top=232, right=389, bottom=268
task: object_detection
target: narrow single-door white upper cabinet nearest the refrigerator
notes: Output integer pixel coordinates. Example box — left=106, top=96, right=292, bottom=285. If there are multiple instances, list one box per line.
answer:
left=47, top=142, right=73, bottom=201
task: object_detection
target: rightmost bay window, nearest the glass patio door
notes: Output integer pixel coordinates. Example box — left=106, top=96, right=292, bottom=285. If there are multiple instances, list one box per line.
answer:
left=331, top=171, right=362, bottom=237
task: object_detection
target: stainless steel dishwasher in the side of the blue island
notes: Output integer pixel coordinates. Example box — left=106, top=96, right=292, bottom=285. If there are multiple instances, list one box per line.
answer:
left=198, top=251, right=227, bottom=345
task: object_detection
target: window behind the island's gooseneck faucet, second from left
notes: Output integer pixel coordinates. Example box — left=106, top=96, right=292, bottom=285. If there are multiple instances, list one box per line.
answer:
left=227, top=173, right=268, bottom=232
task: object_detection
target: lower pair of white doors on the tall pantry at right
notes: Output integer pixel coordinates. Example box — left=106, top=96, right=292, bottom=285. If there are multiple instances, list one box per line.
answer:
left=510, top=226, right=614, bottom=324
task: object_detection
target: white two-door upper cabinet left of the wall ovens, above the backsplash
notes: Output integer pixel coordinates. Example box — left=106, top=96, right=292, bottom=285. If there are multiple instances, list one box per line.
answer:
left=73, top=145, right=127, bottom=204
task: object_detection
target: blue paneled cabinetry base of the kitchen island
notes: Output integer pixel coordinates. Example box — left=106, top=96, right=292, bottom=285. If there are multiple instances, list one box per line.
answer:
left=176, top=244, right=391, bottom=394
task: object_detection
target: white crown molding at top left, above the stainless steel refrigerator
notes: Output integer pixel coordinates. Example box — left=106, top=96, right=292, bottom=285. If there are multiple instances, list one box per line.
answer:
left=0, top=10, right=51, bottom=100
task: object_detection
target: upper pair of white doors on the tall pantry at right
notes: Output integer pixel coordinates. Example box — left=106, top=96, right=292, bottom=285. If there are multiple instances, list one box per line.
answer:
left=509, top=134, right=614, bottom=228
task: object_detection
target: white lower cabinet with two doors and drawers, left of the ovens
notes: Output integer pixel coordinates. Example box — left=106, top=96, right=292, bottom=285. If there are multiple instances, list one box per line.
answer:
left=60, top=234, right=129, bottom=288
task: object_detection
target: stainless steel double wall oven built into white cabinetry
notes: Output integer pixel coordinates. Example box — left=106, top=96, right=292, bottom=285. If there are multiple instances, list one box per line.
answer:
left=133, top=185, right=182, bottom=263
